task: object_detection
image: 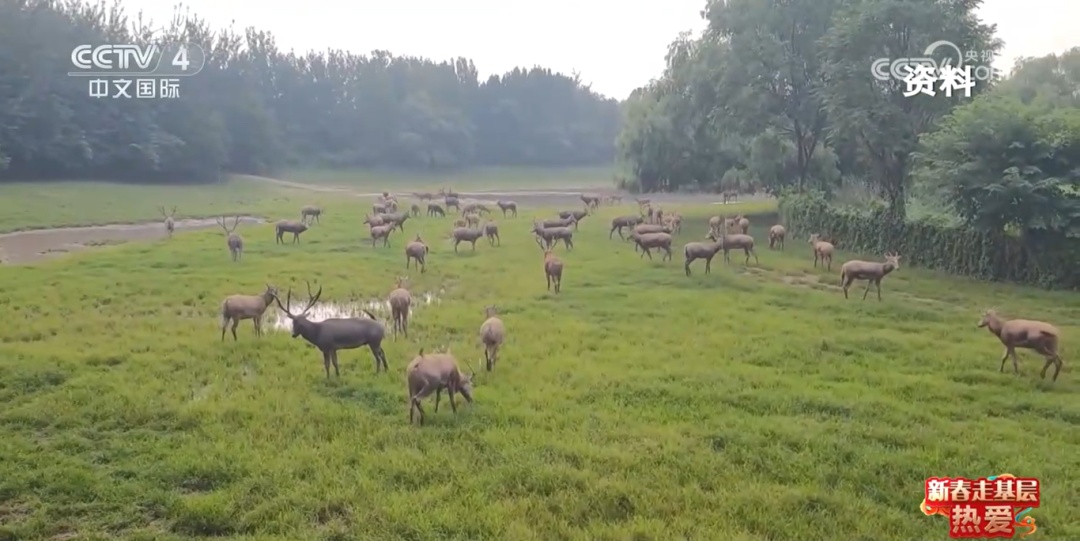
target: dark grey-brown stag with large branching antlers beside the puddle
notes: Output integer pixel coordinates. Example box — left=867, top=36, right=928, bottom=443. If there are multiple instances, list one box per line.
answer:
left=274, top=283, right=390, bottom=379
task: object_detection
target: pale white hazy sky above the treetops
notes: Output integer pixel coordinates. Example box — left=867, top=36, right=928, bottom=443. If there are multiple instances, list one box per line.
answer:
left=122, top=0, right=1080, bottom=99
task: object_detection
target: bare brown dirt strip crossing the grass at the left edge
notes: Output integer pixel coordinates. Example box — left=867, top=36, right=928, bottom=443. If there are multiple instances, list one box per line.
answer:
left=0, top=216, right=266, bottom=265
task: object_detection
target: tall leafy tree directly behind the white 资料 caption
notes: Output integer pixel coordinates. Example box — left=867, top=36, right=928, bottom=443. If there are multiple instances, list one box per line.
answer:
left=822, top=0, right=1000, bottom=220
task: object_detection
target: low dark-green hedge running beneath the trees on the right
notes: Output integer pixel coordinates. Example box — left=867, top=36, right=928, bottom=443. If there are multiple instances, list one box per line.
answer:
left=780, top=194, right=1080, bottom=289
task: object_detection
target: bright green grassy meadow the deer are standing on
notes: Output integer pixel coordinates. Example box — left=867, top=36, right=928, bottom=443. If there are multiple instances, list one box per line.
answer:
left=0, top=173, right=1080, bottom=541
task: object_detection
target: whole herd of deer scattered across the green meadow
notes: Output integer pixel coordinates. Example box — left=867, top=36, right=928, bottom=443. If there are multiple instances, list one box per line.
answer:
left=158, top=190, right=1063, bottom=424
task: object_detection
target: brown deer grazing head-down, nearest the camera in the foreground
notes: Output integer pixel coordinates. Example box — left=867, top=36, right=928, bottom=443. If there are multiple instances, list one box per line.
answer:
left=405, top=348, right=476, bottom=427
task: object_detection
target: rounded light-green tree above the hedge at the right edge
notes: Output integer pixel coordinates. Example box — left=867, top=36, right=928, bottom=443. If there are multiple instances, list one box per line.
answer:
left=916, top=95, right=1080, bottom=232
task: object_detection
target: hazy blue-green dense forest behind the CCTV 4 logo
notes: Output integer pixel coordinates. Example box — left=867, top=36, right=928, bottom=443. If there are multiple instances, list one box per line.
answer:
left=0, top=0, right=621, bottom=181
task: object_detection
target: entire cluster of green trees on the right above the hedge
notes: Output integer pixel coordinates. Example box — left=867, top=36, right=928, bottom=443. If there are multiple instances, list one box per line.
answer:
left=618, top=0, right=1080, bottom=234
